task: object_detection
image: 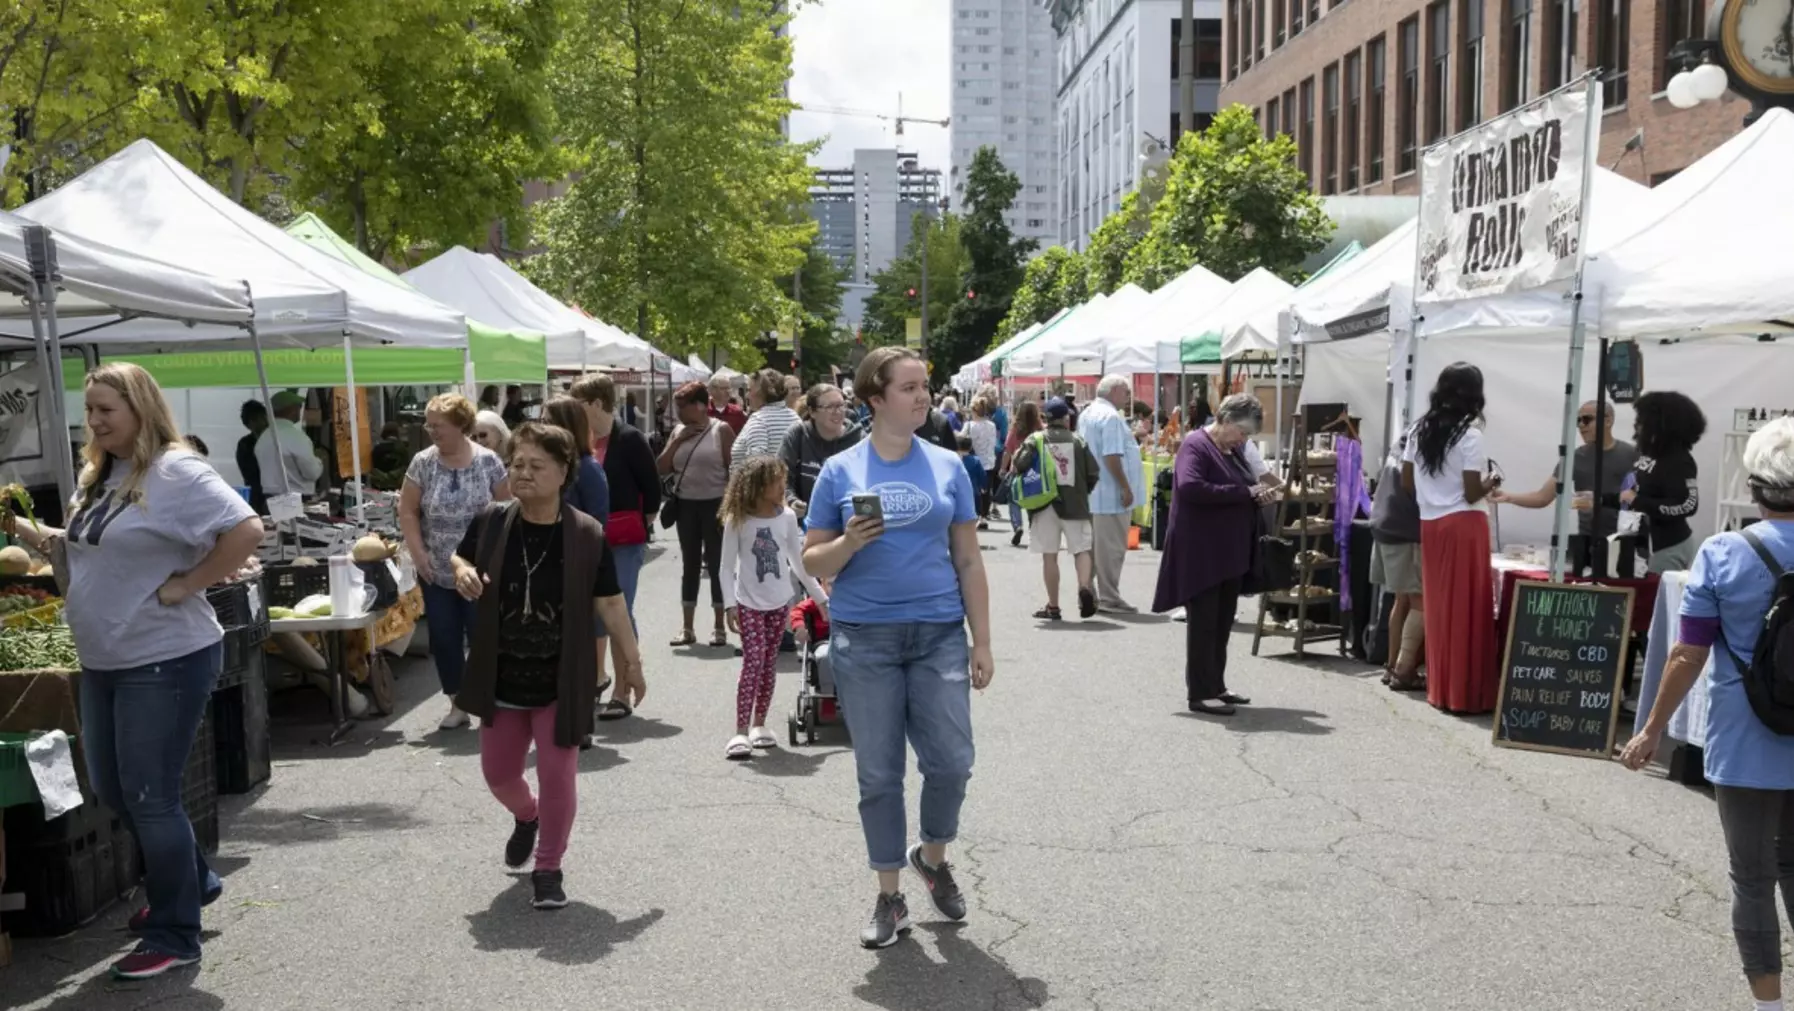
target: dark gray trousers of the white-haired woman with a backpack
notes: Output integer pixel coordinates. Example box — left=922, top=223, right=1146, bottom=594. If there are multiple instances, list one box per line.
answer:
left=1713, top=787, right=1794, bottom=977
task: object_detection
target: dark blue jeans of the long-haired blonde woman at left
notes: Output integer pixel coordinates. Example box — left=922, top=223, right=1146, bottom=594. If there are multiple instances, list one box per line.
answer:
left=81, top=644, right=224, bottom=959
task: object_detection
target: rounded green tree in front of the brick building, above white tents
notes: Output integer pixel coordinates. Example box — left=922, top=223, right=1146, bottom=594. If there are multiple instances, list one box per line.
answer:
left=1105, top=106, right=1333, bottom=290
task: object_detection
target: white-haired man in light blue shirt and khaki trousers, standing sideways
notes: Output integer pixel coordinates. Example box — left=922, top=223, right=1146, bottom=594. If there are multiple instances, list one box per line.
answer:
left=1078, top=375, right=1146, bottom=615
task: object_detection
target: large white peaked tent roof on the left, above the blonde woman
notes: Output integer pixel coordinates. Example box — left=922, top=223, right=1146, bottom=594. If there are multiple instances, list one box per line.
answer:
left=20, top=140, right=466, bottom=348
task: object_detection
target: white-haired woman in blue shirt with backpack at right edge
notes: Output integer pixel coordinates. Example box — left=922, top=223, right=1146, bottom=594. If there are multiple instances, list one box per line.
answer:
left=1620, top=418, right=1794, bottom=1011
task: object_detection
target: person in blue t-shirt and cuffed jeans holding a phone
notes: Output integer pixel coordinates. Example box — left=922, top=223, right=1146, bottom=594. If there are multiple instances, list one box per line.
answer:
left=804, top=348, right=996, bottom=948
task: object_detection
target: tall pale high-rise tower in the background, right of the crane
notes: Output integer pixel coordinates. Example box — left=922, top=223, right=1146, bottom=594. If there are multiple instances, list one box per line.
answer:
left=949, top=0, right=1054, bottom=249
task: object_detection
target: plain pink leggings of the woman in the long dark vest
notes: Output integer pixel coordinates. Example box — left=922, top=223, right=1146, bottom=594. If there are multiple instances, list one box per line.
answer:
left=479, top=702, right=577, bottom=871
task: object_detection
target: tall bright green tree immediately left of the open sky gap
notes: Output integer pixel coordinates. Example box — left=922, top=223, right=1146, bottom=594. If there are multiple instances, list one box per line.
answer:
left=529, top=0, right=816, bottom=355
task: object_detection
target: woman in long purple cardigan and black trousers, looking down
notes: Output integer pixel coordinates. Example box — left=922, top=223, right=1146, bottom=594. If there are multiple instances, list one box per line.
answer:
left=1152, top=393, right=1276, bottom=715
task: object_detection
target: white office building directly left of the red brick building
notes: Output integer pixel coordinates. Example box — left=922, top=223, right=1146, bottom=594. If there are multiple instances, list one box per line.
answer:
left=1037, top=0, right=1222, bottom=249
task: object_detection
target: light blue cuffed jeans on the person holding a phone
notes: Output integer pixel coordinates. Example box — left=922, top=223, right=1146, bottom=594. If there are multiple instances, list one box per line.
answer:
left=829, top=620, right=972, bottom=871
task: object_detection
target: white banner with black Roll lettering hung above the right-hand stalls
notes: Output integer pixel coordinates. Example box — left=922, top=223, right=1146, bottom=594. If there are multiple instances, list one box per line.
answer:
left=1414, top=84, right=1600, bottom=303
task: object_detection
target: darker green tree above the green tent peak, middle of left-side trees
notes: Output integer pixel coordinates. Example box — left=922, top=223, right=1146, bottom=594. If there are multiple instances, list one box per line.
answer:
left=292, top=0, right=570, bottom=260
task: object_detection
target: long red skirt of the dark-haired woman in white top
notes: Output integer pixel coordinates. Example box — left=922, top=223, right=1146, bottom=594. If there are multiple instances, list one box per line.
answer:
left=1421, top=509, right=1500, bottom=713
